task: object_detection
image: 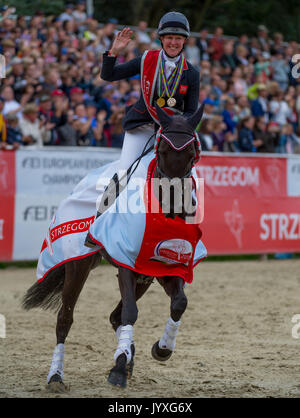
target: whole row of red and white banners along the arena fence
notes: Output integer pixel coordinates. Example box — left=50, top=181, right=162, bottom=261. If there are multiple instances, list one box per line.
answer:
left=0, top=147, right=300, bottom=261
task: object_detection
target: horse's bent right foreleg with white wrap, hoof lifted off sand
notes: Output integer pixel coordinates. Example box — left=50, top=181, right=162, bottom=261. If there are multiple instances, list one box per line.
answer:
left=152, top=277, right=187, bottom=361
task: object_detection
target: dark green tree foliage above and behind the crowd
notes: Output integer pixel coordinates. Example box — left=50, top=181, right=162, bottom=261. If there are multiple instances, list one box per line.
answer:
left=4, top=0, right=300, bottom=42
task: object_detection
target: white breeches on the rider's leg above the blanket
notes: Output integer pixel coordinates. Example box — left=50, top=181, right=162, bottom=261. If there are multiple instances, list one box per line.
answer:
left=119, top=123, right=154, bottom=170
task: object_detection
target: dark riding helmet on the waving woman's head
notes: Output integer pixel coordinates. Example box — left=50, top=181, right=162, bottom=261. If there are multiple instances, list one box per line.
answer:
left=157, top=12, right=190, bottom=38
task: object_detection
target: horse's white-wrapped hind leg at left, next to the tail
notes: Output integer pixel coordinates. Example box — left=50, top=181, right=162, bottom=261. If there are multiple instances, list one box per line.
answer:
left=47, top=255, right=97, bottom=392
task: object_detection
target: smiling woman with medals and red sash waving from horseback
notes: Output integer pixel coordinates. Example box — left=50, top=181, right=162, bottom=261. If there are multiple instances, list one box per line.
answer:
left=101, top=12, right=200, bottom=170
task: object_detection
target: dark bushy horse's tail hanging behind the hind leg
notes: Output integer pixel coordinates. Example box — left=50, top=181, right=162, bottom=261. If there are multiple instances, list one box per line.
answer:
left=22, top=265, right=65, bottom=311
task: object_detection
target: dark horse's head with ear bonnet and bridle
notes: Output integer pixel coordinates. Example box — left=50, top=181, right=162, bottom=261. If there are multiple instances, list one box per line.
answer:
left=155, top=104, right=204, bottom=178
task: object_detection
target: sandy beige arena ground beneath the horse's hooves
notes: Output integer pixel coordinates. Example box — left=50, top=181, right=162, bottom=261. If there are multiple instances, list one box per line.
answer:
left=0, top=259, right=300, bottom=398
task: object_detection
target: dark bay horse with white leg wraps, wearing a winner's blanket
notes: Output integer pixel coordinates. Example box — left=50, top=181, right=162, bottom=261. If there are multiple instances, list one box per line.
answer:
left=23, top=105, right=203, bottom=392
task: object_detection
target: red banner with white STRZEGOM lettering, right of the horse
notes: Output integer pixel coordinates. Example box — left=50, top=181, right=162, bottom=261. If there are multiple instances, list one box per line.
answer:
left=197, top=155, right=300, bottom=254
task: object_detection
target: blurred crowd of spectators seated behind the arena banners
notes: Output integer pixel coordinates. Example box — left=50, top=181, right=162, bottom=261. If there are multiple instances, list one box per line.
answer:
left=0, top=0, right=300, bottom=153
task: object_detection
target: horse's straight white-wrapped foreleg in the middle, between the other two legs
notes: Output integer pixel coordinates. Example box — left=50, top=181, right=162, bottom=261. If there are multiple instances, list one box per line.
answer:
left=108, top=267, right=138, bottom=387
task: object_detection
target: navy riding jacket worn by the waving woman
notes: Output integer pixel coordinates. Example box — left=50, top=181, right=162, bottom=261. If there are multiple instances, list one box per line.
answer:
left=101, top=52, right=200, bottom=131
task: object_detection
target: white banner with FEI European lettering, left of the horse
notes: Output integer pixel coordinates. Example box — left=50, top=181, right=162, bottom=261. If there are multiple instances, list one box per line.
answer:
left=13, top=147, right=120, bottom=260
